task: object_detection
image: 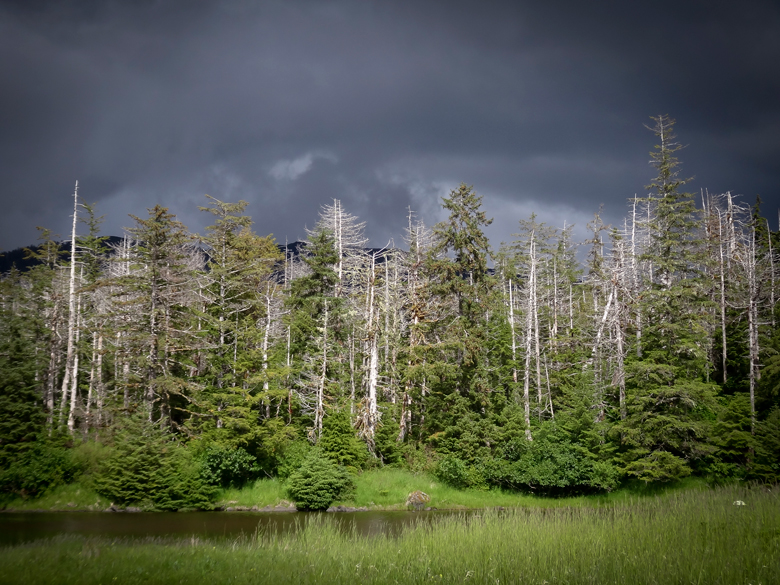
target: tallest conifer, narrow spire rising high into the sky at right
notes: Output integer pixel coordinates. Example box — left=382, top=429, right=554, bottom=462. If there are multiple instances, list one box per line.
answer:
left=613, top=116, right=716, bottom=481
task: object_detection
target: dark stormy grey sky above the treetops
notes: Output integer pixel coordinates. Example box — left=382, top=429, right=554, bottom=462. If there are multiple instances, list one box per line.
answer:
left=0, top=0, right=780, bottom=249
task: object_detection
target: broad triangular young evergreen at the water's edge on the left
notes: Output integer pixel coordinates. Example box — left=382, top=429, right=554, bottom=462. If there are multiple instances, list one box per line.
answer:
left=94, top=416, right=215, bottom=510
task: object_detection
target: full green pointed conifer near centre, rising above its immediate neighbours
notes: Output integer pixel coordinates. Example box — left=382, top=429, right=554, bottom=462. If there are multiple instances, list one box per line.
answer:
left=426, top=184, right=497, bottom=452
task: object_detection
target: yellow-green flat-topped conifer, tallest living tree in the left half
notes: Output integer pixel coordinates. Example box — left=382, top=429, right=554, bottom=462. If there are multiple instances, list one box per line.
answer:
left=189, top=196, right=281, bottom=455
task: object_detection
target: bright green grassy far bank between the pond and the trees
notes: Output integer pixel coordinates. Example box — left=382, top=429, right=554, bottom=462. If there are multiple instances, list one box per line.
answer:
left=0, top=467, right=707, bottom=512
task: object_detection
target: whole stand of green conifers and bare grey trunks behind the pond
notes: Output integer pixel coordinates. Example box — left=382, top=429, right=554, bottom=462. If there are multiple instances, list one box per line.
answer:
left=0, top=116, right=780, bottom=509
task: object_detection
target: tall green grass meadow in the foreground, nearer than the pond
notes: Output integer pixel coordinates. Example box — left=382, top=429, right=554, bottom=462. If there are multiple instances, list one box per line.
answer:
left=0, top=487, right=780, bottom=585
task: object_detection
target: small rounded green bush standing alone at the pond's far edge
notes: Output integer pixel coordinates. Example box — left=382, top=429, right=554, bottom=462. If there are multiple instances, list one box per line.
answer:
left=287, top=449, right=355, bottom=510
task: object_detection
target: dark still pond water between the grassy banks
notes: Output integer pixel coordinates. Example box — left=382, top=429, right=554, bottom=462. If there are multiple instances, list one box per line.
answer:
left=0, top=510, right=470, bottom=546
